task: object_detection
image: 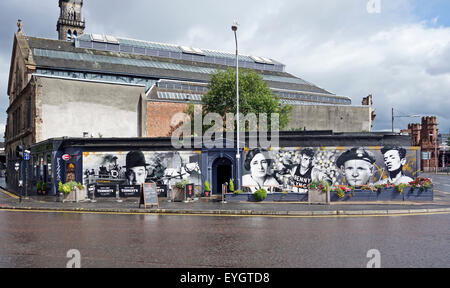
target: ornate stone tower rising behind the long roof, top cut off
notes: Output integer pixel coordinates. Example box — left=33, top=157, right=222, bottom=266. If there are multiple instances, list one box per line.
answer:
left=56, top=0, right=85, bottom=41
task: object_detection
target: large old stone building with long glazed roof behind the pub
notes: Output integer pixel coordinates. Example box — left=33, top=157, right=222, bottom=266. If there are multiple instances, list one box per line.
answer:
left=5, top=0, right=374, bottom=194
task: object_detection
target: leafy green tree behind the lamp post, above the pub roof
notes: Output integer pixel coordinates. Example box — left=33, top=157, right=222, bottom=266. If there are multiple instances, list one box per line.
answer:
left=199, top=68, right=293, bottom=130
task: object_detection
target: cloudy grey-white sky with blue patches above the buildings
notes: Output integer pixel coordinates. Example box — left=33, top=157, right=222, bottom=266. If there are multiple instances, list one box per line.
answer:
left=0, top=0, right=450, bottom=135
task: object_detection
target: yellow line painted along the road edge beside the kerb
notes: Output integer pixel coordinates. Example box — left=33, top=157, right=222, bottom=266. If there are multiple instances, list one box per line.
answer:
left=0, top=208, right=450, bottom=218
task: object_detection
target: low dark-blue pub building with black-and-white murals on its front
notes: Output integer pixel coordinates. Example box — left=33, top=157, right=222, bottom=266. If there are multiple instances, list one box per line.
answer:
left=18, top=131, right=420, bottom=200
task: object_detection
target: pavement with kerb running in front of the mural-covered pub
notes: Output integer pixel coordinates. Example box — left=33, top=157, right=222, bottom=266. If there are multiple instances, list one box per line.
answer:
left=0, top=175, right=450, bottom=216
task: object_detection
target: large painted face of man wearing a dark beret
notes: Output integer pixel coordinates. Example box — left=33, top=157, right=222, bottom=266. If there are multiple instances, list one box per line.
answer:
left=336, top=147, right=375, bottom=187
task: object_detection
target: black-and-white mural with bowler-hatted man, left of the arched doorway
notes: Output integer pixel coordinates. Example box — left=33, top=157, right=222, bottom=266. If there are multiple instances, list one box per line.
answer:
left=83, top=151, right=202, bottom=187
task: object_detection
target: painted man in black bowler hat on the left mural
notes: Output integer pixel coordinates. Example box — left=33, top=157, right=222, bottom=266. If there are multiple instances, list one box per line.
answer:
left=125, top=151, right=148, bottom=185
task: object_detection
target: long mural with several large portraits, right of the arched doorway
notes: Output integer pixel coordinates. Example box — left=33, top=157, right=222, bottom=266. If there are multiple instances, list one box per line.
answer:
left=242, top=147, right=418, bottom=193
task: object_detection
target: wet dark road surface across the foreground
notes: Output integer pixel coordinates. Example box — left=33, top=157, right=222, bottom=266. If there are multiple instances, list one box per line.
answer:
left=0, top=211, right=450, bottom=268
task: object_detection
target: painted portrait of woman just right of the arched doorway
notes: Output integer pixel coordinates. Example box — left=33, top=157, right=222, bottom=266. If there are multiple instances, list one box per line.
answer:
left=242, top=149, right=280, bottom=193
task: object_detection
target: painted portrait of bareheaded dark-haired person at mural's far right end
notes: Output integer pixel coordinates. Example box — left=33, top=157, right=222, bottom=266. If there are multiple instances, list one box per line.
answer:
left=377, top=146, right=413, bottom=185
